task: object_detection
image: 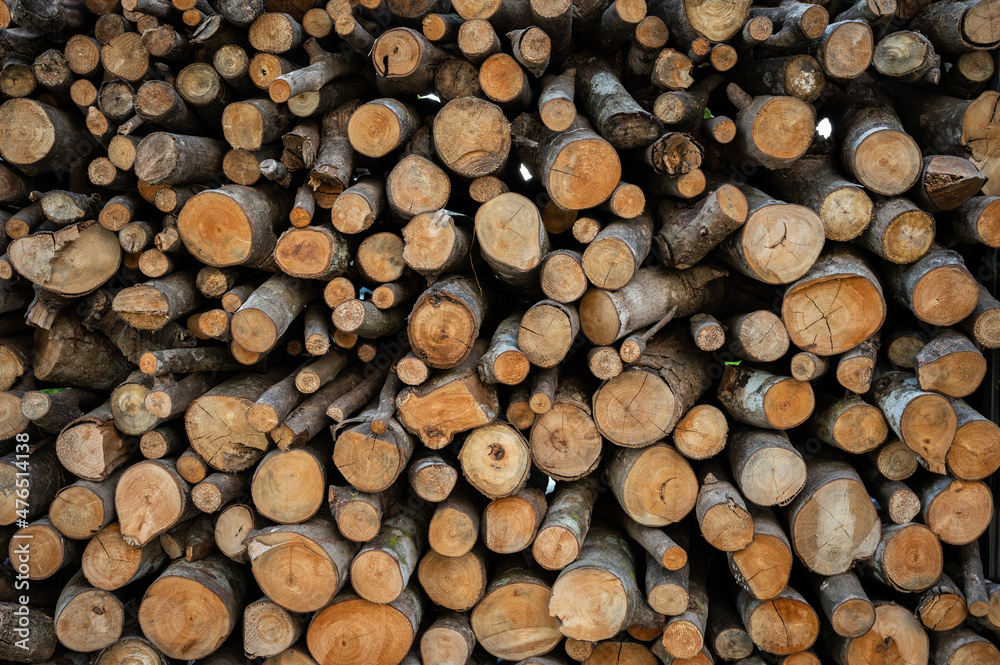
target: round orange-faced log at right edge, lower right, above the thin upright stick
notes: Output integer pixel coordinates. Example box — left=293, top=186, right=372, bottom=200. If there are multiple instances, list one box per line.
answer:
left=914, top=476, right=993, bottom=545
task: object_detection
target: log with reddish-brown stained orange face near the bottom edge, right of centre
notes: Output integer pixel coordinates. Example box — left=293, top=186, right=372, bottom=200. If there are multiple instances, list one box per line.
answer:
left=737, top=587, right=819, bottom=656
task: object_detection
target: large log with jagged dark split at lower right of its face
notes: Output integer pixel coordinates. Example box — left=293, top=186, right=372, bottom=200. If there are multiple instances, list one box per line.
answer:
left=184, top=373, right=279, bottom=471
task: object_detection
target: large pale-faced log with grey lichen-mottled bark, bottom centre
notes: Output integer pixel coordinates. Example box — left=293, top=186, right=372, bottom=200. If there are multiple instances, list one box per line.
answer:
left=549, top=528, right=640, bottom=641
